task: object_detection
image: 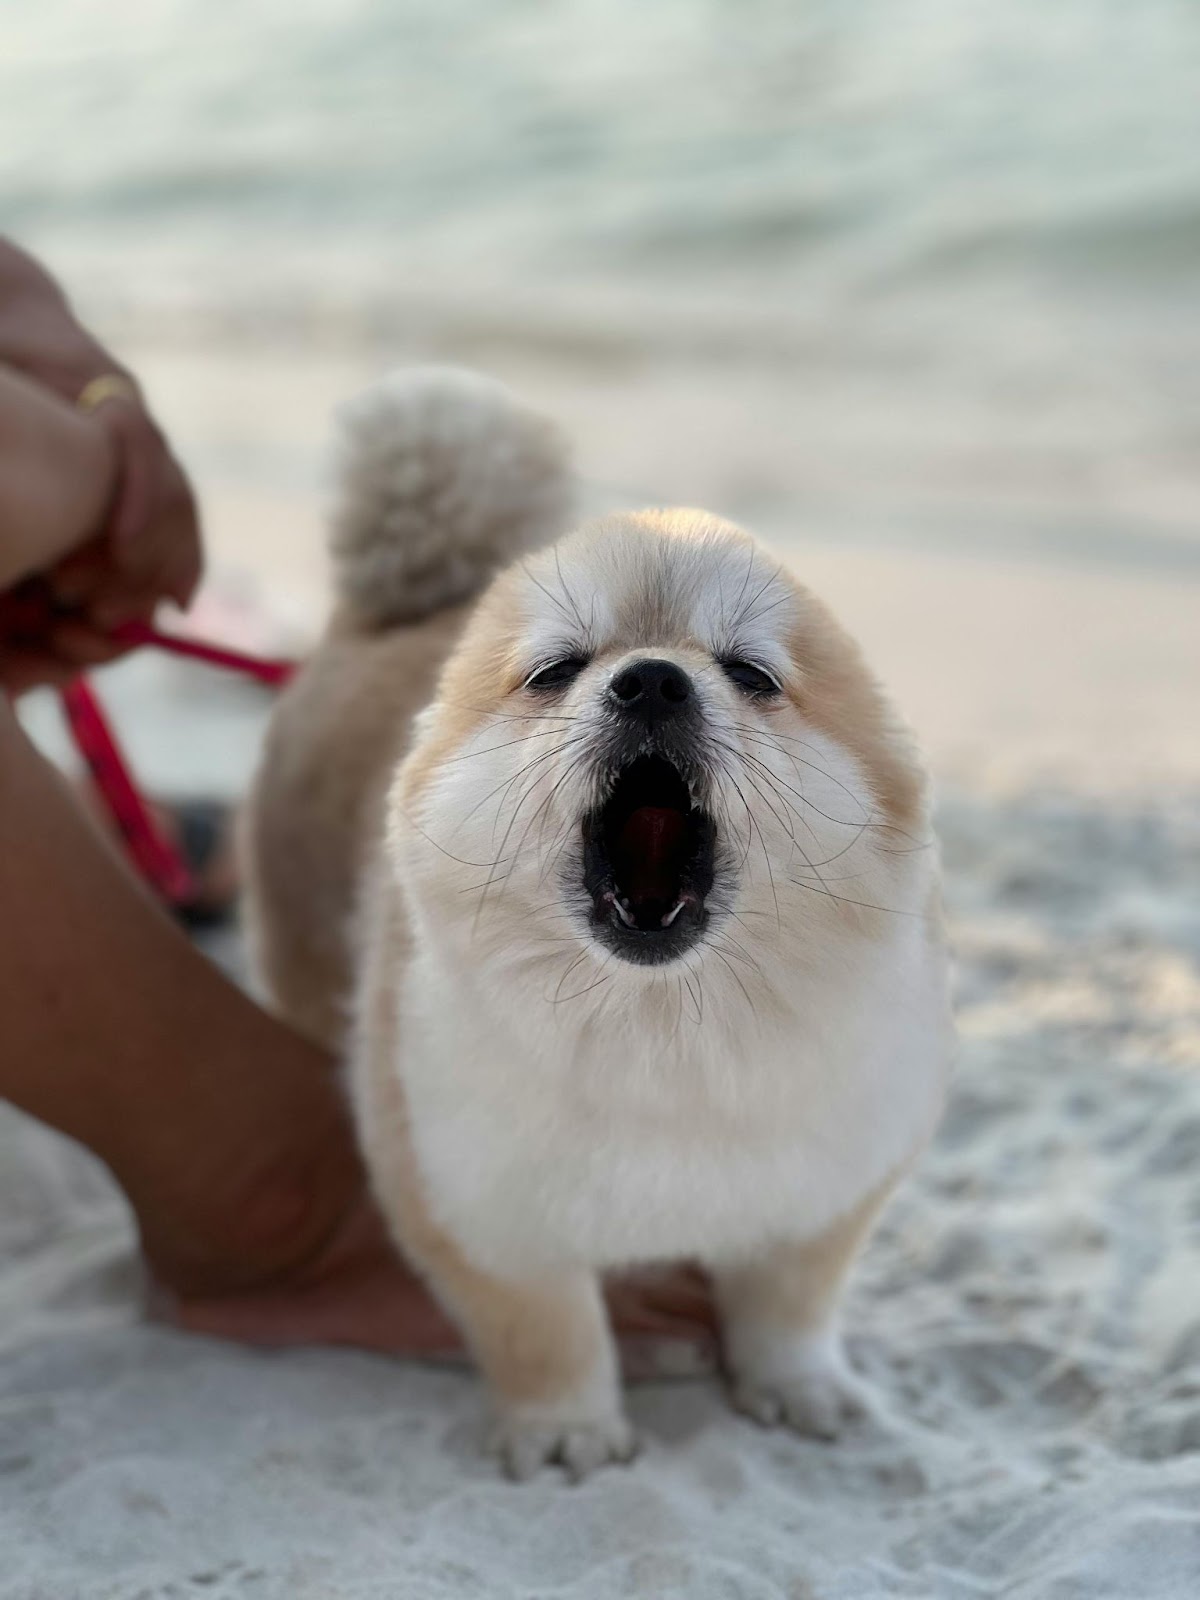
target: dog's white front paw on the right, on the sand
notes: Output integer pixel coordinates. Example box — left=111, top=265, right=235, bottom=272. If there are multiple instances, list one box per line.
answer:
left=733, top=1339, right=875, bottom=1438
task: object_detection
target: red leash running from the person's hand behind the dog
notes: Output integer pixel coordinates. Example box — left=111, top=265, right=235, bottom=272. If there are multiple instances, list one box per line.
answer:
left=59, top=622, right=296, bottom=906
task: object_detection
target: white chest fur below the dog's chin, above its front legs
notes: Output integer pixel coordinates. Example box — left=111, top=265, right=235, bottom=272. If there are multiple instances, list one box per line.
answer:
left=395, top=930, right=946, bottom=1274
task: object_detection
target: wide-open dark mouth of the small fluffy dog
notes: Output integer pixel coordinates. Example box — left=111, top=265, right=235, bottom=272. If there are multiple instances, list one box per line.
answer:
left=584, top=755, right=717, bottom=963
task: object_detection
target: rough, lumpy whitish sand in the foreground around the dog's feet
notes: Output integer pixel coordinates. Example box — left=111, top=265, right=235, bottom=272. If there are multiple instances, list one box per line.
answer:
left=0, top=795, right=1200, bottom=1600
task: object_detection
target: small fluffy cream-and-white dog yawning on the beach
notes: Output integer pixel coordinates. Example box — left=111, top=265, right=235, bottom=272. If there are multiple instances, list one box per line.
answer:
left=250, top=371, right=949, bottom=1477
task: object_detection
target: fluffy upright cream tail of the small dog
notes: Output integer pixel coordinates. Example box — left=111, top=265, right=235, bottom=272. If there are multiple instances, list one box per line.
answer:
left=330, top=366, right=574, bottom=632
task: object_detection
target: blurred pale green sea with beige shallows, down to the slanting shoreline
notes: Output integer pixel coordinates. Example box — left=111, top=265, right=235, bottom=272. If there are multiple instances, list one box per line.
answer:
left=0, top=0, right=1200, bottom=563
